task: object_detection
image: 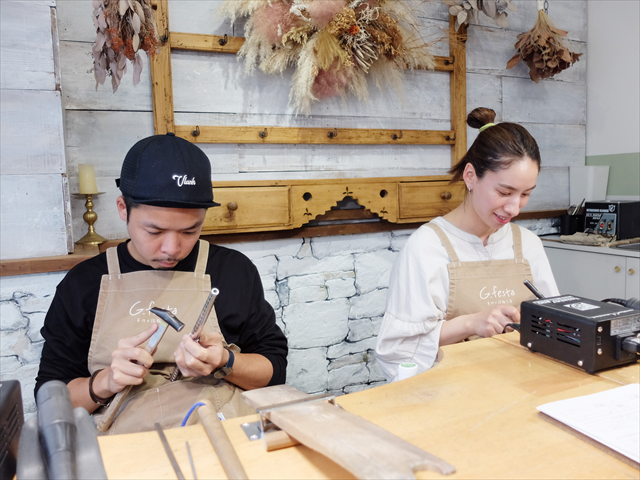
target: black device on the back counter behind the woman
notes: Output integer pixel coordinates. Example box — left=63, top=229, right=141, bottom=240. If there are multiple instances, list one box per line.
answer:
left=584, top=200, right=640, bottom=240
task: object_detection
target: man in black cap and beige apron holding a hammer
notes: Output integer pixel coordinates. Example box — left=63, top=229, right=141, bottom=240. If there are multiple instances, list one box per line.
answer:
left=36, top=133, right=287, bottom=433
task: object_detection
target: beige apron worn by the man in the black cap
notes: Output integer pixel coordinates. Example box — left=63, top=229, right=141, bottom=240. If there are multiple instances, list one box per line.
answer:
left=88, top=240, right=255, bottom=435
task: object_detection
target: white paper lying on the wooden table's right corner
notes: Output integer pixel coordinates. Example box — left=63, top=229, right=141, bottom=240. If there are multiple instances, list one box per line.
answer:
left=538, top=383, right=640, bottom=463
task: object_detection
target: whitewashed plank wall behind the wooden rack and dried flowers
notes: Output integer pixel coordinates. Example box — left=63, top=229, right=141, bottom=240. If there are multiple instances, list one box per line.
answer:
left=57, top=0, right=587, bottom=242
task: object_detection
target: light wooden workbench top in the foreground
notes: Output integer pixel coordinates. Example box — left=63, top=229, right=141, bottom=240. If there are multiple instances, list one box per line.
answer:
left=99, top=333, right=640, bottom=479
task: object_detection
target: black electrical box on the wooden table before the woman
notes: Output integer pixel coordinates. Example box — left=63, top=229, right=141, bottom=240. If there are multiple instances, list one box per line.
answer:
left=520, top=295, right=640, bottom=373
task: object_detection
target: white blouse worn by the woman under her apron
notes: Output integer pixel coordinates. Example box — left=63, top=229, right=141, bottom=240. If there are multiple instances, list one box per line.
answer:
left=376, top=217, right=559, bottom=381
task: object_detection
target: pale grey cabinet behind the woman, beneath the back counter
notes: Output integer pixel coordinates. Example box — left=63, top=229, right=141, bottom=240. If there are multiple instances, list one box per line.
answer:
left=543, top=242, right=640, bottom=300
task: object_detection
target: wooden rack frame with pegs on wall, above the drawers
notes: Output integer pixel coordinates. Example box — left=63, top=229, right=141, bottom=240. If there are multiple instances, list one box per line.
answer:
left=150, top=0, right=467, bottom=165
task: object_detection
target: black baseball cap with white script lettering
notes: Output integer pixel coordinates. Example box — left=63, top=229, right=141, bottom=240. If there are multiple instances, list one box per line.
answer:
left=116, top=133, right=220, bottom=208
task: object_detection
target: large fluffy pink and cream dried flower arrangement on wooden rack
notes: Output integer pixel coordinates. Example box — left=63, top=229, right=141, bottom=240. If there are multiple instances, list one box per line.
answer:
left=220, top=0, right=435, bottom=114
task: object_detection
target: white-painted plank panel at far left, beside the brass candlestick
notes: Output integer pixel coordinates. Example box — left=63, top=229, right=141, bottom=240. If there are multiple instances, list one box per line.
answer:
left=0, top=0, right=72, bottom=259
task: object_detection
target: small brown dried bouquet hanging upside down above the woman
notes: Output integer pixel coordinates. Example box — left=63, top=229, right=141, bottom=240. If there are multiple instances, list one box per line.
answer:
left=507, top=10, right=582, bottom=83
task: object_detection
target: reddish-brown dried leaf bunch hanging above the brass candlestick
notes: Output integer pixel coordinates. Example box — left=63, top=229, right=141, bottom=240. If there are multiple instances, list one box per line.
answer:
left=92, top=0, right=158, bottom=93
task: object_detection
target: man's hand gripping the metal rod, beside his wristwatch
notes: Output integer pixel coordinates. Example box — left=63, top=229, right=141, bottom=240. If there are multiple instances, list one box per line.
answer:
left=173, top=332, right=229, bottom=377
